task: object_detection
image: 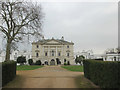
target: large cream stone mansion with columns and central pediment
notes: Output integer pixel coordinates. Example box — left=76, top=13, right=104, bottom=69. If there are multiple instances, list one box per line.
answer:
left=32, top=37, right=74, bottom=65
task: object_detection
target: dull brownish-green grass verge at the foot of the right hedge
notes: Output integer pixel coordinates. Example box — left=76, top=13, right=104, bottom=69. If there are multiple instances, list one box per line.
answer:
left=75, top=75, right=99, bottom=88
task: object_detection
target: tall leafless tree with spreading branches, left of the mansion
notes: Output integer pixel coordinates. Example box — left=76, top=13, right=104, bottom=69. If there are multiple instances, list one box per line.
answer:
left=0, top=1, right=43, bottom=61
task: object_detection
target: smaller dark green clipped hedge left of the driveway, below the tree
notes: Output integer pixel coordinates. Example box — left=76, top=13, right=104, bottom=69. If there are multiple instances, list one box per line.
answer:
left=2, top=61, right=16, bottom=86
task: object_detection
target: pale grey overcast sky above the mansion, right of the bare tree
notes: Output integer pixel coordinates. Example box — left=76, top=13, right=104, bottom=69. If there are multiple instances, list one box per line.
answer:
left=0, top=2, right=118, bottom=54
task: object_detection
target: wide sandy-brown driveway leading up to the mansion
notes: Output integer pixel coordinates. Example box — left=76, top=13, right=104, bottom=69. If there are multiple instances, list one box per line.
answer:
left=5, top=66, right=97, bottom=88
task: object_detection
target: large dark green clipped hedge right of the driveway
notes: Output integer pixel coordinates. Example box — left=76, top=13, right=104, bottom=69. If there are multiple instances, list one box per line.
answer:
left=83, top=60, right=120, bottom=88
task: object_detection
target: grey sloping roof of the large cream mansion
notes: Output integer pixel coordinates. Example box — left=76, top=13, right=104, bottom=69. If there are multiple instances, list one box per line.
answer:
left=32, top=38, right=74, bottom=45
